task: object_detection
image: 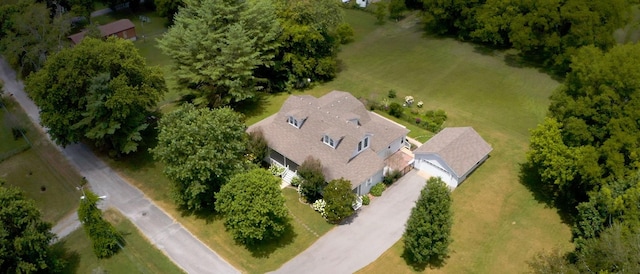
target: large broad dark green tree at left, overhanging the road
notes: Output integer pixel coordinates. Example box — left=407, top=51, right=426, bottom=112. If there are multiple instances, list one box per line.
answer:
left=26, top=38, right=166, bottom=154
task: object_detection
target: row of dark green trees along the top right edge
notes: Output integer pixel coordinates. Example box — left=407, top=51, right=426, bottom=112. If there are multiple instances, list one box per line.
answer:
left=418, top=0, right=630, bottom=74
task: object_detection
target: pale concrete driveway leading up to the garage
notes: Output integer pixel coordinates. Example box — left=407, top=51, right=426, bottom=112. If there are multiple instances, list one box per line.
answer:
left=275, top=170, right=426, bottom=273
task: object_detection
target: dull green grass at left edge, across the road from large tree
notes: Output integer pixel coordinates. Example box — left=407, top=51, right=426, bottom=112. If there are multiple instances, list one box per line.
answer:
left=0, top=96, right=81, bottom=223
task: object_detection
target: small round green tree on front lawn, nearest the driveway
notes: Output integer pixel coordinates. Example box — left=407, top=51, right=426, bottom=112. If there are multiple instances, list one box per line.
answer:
left=215, top=168, right=289, bottom=246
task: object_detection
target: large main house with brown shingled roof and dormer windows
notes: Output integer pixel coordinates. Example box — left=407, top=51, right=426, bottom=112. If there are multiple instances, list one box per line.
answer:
left=247, top=91, right=409, bottom=195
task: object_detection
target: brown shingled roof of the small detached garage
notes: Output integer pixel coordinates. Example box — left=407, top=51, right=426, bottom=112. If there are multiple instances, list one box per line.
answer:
left=413, top=127, right=493, bottom=176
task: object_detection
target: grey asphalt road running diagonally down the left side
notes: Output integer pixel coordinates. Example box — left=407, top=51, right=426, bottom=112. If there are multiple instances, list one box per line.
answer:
left=0, top=59, right=238, bottom=273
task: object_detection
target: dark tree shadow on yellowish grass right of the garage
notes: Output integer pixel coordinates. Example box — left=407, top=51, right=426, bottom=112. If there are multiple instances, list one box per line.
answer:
left=519, top=163, right=574, bottom=225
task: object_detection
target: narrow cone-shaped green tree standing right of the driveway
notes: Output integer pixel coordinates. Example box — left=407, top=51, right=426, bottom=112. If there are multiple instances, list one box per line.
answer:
left=403, top=177, right=453, bottom=264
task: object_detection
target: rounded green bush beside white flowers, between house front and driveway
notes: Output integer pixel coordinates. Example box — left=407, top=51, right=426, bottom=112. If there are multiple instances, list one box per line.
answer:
left=323, top=179, right=357, bottom=223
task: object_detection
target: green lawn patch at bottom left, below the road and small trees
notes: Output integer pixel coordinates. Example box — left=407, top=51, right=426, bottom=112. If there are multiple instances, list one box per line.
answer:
left=55, top=209, right=184, bottom=273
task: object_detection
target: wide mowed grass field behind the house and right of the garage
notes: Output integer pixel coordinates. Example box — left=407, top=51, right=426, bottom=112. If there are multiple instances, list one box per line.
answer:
left=322, top=10, right=572, bottom=273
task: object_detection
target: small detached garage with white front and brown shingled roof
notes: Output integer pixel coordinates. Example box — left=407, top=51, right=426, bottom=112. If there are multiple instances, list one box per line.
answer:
left=413, top=127, right=493, bottom=188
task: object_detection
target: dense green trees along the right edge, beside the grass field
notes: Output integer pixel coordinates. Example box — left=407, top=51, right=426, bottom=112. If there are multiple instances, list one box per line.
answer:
left=523, top=45, right=640, bottom=273
